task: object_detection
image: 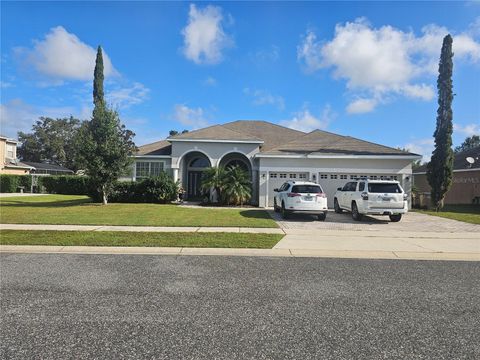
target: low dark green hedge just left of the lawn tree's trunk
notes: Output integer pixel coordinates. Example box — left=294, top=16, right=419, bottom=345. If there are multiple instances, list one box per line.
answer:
left=40, top=175, right=92, bottom=196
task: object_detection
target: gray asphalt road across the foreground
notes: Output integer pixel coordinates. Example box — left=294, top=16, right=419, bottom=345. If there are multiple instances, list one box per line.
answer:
left=0, top=254, right=480, bottom=359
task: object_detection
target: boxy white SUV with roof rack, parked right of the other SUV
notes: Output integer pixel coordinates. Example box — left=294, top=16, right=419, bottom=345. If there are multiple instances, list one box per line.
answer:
left=333, top=180, right=408, bottom=222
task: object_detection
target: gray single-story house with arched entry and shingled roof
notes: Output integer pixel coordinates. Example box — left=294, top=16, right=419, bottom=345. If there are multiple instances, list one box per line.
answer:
left=131, top=120, right=420, bottom=207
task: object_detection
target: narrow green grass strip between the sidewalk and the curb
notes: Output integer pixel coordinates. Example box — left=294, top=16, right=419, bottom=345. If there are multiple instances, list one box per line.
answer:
left=0, top=230, right=283, bottom=249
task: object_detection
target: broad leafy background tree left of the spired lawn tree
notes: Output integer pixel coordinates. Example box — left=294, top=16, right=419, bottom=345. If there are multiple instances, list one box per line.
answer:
left=18, top=116, right=81, bottom=170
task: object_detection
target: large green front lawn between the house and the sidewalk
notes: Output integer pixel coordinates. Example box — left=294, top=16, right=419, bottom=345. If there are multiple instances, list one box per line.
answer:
left=0, top=195, right=278, bottom=228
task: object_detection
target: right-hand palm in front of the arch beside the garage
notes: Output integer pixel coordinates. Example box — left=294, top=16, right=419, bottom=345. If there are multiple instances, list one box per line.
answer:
left=223, top=165, right=252, bottom=206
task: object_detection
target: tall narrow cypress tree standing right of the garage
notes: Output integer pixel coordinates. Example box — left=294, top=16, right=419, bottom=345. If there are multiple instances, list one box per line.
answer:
left=427, top=35, right=453, bottom=211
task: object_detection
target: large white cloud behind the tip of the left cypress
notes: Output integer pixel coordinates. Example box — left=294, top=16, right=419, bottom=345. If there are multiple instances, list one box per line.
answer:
left=15, top=26, right=118, bottom=84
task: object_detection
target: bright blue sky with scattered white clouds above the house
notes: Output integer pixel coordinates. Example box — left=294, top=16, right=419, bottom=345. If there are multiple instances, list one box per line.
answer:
left=1, top=1, right=480, bottom=158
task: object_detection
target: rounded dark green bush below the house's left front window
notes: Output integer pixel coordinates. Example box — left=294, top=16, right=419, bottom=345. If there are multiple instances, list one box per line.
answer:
left=109, top=172, right=178, bottom=204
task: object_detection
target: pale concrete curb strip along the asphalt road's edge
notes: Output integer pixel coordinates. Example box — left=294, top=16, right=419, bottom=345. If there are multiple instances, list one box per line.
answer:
left=0, top=245, right=480, bottom=261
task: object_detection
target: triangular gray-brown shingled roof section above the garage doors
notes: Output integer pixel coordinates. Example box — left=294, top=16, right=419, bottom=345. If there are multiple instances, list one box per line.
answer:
left=265, top=130, right=417, bottom=155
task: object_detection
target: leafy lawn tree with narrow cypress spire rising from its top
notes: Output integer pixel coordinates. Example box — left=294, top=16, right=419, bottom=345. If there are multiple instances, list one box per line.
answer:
left=78, top=46, right=136, bottom=205
